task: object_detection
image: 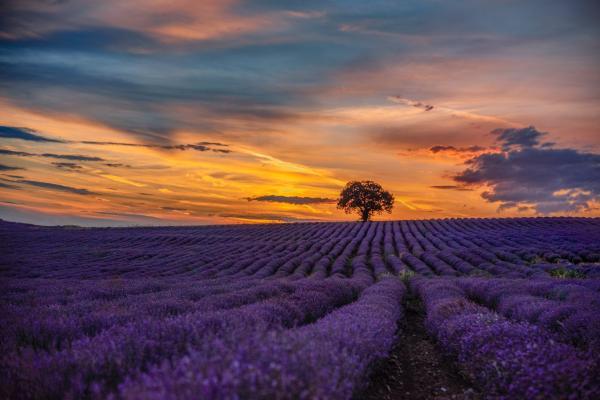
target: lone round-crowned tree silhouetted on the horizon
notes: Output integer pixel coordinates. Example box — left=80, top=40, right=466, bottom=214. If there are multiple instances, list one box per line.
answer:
left=337, top=181, right=394, bottom=221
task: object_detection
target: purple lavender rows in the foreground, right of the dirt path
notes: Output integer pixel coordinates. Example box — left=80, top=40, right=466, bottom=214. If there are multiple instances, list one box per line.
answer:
left=411, top=278, right=600, bottom=399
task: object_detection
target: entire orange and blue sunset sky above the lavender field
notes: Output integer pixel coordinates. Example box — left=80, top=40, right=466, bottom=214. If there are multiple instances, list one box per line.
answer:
left=0, top=0, right=600, bottom=226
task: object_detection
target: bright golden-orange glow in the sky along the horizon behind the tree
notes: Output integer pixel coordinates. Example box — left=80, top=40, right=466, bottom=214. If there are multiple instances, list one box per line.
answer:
left=0, top=97, right=596, bottom=224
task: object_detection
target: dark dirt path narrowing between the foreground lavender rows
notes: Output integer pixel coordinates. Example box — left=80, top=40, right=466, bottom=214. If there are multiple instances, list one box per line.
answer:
left=357, top=296, right=481, bottom=400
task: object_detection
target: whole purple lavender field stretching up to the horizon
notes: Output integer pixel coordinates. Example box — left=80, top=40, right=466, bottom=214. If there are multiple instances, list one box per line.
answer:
left=0, top=218, right=600, bottom=399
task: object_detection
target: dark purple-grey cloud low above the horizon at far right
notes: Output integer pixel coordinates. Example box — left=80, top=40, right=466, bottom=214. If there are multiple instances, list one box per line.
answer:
left=454, top=127, right=600, bottom=214
